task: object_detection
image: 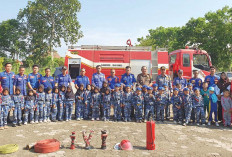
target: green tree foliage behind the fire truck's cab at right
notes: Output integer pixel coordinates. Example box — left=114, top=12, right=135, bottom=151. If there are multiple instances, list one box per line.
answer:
left=138, top=6, right=232, bottom=70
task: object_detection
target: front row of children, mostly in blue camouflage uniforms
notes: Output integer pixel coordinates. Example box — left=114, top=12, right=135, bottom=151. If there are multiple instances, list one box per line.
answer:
left=0, top=82, right=232, bottom=130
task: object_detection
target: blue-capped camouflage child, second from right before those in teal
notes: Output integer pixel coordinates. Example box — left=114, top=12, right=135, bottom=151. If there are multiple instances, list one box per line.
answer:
left=182, top=88, right=192, bottom=126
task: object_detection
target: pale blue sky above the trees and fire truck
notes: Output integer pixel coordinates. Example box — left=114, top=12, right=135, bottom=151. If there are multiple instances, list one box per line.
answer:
left=0, top=0, right=232, bottom=56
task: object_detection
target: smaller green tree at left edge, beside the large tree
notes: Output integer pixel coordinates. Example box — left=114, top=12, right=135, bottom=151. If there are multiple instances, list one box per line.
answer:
left=0, top=19, right=26, bottom=59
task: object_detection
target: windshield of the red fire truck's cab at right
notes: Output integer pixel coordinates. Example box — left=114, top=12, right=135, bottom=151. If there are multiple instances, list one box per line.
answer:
left=193, top=54, right=210, bottom=71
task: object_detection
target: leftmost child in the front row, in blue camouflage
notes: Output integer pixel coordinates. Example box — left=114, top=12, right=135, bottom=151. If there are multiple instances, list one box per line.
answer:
left=0, top=88, right=12, bottom=130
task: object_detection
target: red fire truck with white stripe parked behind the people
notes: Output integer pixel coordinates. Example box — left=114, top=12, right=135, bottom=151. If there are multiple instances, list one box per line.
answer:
left=65, top=45, right=212, bottom=80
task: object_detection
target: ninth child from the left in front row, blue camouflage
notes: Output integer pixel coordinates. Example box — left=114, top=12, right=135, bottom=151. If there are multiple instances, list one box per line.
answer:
left=75, top=84, right=84, bottom=121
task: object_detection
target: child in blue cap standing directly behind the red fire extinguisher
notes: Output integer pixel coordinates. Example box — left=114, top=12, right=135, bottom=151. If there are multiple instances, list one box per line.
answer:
left=144, top=87, right=155, bottom=122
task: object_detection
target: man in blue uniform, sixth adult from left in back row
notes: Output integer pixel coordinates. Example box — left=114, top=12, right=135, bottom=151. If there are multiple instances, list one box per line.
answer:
left=74, top=68, right=90, bottom=90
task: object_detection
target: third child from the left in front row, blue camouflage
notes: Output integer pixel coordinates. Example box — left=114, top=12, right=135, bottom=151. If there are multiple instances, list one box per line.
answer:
left=24, top=89, right=35, bottom=125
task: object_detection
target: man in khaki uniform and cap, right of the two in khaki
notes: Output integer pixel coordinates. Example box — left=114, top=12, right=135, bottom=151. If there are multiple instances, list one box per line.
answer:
left=156, top=66, right=173, bottom=95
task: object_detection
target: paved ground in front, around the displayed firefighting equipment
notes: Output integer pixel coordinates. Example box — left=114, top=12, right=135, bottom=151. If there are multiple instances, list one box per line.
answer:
left=0, top=120, right=232, bottom=157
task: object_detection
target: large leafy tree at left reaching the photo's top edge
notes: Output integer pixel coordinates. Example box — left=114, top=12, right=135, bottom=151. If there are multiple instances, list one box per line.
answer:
left=18, top=0, right=83, bottom=62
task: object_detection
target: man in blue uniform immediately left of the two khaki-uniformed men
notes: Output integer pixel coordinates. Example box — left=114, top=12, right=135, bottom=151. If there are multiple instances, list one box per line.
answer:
left=121, top=66, right=136, bottom=87
